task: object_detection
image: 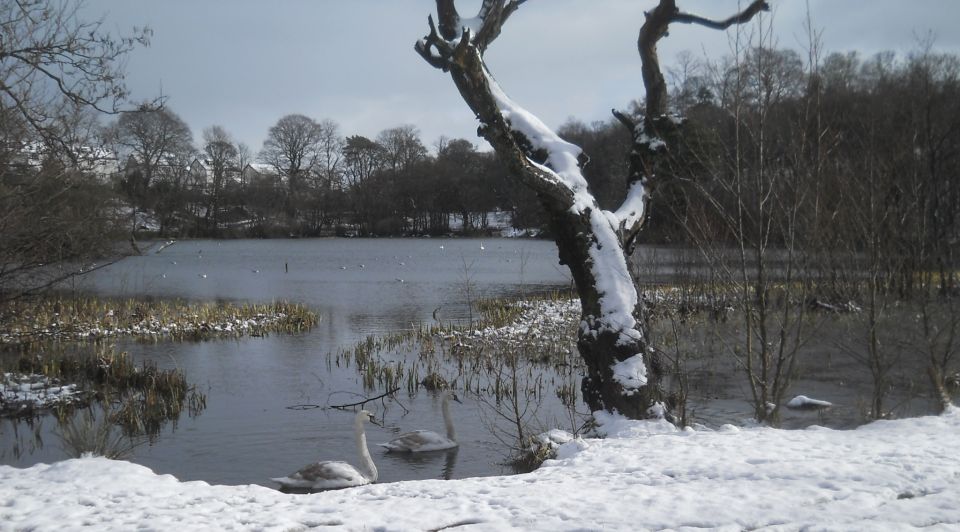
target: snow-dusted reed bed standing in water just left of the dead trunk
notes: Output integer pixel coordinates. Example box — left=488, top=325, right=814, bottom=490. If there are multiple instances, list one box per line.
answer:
left=327, top=293, right=580, bottom=402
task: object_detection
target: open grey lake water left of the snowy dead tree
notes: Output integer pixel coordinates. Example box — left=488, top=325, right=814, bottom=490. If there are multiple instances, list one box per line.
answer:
left=0, top=239, right=569, bottom=485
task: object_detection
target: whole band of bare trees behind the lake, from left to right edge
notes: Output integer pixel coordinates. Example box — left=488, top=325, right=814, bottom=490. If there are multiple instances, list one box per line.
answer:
left=0, top=0, right=960, bottom=308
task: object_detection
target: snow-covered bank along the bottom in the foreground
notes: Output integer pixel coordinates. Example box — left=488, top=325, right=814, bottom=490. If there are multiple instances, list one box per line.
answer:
left=0, top=408, right=960, bottom=531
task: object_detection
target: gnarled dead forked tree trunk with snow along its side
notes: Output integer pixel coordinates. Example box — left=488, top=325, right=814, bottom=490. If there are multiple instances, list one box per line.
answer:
left=416, top=0, right=768, bottom=418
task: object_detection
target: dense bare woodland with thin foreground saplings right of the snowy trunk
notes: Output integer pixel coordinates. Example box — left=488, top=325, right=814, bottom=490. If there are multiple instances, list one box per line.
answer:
left=654, top=41, right=960, bottom=423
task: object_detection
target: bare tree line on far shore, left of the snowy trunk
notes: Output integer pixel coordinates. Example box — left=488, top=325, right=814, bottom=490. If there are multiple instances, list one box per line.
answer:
left=104, top=108, right=537, bottom=237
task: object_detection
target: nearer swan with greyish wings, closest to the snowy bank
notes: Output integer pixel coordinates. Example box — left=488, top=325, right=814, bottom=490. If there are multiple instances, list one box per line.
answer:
left=270, top=410, right=378, bottom=490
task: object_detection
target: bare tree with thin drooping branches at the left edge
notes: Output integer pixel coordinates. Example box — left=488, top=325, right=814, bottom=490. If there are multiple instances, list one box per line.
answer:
left=0, top=0, right=150, bottom=301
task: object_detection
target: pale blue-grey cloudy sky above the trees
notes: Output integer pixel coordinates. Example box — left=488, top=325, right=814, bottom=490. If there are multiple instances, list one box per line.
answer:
left=84, top=0, right=960, bottom=152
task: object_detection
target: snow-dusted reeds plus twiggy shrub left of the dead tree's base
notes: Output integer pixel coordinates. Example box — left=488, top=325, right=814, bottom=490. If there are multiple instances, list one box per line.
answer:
left=328, top=294, right=583, bottom=463
